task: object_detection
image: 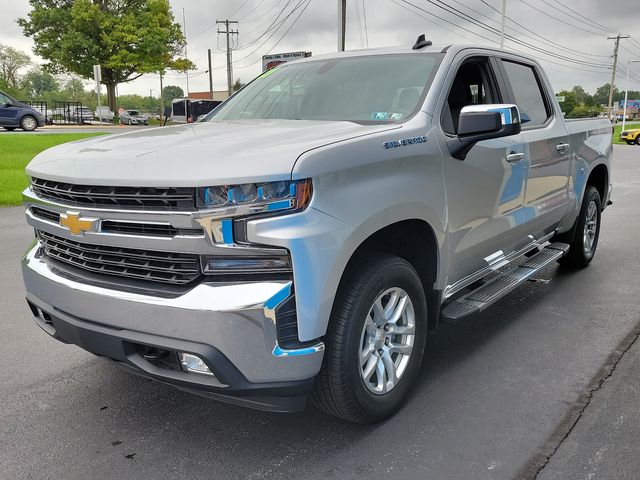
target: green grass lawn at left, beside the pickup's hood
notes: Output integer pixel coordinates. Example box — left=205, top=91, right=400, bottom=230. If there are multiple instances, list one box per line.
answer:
left=0, top=133, right=102, bottom=206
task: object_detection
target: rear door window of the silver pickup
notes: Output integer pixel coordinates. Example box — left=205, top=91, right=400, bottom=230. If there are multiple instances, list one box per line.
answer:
left=502, top=60, right=551, bottom=127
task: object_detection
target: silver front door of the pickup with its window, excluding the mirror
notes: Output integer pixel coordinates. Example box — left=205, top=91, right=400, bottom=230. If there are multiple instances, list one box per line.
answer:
left=436, top=55, right=531, bottom=290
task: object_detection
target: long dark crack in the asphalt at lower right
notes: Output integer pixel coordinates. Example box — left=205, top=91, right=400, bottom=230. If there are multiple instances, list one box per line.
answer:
left=515, top=322, right=640, bottom=480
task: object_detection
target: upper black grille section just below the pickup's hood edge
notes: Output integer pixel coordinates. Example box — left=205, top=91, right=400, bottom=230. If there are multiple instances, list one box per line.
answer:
left=31, top=178, right=196, bottom=211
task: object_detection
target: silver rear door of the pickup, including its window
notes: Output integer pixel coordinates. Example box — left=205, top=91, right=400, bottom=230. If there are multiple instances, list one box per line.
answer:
left=499, top=57, right=571, bottom=238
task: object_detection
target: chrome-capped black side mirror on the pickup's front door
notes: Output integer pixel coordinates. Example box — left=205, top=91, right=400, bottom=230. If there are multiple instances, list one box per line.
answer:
left=447, top=104, right=522, bottom=160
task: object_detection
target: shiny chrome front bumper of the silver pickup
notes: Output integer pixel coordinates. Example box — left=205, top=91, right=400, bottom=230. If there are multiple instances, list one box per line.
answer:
left=22, top=242, right=324, bottom=383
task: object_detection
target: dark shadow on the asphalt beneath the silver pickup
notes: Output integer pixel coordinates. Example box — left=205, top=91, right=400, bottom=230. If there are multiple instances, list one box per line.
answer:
left=61, top=267, right=584, bottom=478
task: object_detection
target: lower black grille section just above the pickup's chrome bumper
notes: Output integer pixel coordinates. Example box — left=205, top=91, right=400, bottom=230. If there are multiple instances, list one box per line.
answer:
left=37, top=230, right=201, bottom=285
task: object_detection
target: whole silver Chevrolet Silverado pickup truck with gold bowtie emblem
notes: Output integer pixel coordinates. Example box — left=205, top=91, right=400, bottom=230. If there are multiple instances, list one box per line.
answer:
left=22, top=38, right=612, bottom=423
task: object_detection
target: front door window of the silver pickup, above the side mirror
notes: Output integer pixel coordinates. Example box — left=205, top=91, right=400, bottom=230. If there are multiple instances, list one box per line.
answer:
left=440, top=58, right=498, bottom=135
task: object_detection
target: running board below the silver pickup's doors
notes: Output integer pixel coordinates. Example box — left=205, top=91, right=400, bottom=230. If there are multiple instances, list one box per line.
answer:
left=441, top=243, right=569, bottom=323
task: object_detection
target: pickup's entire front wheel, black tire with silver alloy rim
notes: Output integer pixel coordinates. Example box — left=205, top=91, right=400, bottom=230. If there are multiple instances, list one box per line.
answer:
left=311, top=253, right=427, bottom=423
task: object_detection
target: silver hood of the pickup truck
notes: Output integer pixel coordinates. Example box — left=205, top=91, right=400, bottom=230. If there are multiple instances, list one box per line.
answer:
left=27, top=120, right=400, bottom=187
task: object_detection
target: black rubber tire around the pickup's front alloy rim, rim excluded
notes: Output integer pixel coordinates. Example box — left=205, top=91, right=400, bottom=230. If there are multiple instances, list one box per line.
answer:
left=311, top=253, right=427, bottom=424
